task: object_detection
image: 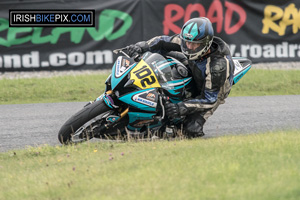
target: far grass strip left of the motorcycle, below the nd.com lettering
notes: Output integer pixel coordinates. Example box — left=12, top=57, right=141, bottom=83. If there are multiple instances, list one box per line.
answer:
left=0, top=74, right=109, bottom=104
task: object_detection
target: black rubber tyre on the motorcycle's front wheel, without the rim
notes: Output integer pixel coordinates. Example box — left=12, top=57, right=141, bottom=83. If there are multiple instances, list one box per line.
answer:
left=58, top=100, right=111, bottom=144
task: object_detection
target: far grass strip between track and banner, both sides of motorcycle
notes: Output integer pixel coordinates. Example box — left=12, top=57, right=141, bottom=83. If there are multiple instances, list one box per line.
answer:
left=0, top=69, right=300, bottom=104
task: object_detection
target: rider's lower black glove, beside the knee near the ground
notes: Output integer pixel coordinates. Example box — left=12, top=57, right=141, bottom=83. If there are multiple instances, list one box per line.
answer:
left=165, top=102, right=188, bottom=118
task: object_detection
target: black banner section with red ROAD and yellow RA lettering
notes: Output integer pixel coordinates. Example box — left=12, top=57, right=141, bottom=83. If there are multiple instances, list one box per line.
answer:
left=143, top=0, right=300, bottom=63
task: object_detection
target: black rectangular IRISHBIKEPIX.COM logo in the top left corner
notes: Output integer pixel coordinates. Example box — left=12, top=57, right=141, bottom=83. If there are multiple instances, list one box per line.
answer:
left=9, top=10, right=95, bottom=27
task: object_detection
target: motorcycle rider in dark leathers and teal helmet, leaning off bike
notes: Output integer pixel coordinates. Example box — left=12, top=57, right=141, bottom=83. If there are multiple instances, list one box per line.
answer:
left=128, top=17, right=234, bottom=137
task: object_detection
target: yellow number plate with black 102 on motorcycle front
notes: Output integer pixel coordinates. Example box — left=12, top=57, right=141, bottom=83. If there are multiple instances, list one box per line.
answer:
left=130, top=60, right=161, bottom=89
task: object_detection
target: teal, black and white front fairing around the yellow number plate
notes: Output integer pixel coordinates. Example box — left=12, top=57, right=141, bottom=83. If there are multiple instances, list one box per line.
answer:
left=104, top=52, right=192, bottom=131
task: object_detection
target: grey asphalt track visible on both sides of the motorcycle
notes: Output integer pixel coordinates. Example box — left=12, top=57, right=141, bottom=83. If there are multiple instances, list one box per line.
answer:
left=0, top=95, right=300, bottom=152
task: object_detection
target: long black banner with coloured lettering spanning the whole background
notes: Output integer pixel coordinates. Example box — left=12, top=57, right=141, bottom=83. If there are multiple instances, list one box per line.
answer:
left=0, top=0, right=300, bottom=72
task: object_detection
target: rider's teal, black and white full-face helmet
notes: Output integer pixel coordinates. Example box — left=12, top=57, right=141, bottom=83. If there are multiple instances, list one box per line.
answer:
left=180, top=17, right=214, bottom=60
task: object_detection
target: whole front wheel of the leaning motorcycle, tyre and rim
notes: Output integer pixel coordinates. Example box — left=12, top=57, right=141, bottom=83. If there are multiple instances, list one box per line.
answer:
left=58, top=100, right=113, bottom=144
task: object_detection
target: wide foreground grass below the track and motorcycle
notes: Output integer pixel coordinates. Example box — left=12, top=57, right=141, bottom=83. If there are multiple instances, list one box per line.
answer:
left=0, top=131, right=300, bottom=200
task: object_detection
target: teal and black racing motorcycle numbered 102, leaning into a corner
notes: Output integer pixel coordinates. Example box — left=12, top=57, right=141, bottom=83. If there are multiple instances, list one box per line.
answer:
left=58, top=47, right=251, bottom=144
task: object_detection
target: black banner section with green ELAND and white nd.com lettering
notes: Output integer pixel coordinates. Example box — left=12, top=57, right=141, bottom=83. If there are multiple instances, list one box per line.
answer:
left=0, top=0, right=142, bottom=72
